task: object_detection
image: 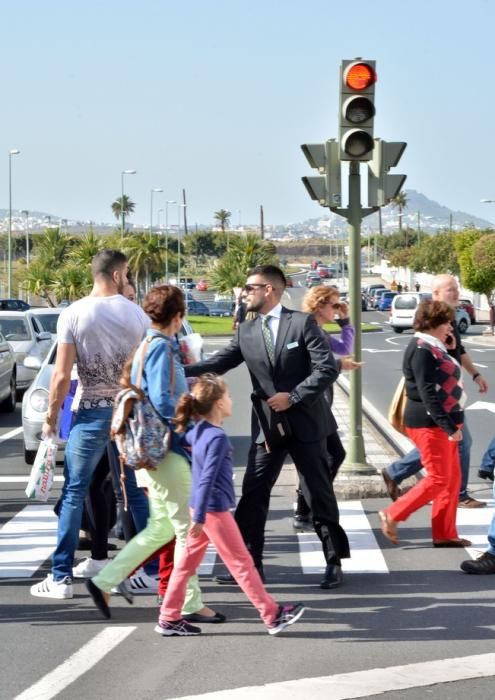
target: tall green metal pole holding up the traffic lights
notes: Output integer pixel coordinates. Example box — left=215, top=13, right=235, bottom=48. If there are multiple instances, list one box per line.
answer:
left=340, top=161, right=376, bottom=475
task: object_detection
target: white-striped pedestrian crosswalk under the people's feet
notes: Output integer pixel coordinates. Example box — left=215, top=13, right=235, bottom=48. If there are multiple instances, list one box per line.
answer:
left=0, top=501, right=493, bottom=579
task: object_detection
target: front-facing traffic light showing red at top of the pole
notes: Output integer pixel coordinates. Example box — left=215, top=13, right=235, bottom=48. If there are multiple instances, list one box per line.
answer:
left=339, top=59, right=376, bottom=161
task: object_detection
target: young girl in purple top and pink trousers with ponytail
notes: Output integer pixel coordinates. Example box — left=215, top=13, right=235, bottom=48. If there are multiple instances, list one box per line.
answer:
left=155, top=374, right=304, bottom=637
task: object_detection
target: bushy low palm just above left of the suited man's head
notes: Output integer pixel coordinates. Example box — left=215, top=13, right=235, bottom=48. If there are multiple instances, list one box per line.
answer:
left=210, top=233, right=276, bottom=292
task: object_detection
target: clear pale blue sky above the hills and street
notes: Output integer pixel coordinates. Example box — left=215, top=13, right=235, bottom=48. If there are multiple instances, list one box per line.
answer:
left=0, top=0, right=495, bottom=226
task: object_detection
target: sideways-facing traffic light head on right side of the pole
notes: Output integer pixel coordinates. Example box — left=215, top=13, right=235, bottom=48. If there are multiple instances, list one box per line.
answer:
left=368, top=139, right=407, bottom=207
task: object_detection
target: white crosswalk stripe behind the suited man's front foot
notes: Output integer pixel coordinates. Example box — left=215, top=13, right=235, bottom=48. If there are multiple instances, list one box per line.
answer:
left=297, top=501, right=389, bottom=574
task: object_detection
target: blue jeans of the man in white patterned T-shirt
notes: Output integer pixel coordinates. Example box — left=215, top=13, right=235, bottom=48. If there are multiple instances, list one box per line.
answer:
left=52, top=408, right=112, bottom=581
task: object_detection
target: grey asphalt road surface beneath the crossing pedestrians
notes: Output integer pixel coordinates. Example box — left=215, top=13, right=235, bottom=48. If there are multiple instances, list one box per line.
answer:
left=0, top=328, right=495, bottom=700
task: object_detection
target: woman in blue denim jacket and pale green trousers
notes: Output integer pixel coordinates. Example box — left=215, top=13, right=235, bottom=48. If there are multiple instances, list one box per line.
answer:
left=86, top=285, right=225, bottom=623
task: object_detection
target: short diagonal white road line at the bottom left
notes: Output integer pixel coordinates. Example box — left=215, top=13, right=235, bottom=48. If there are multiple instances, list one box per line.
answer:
left=14, top=627, right=136, bottom=700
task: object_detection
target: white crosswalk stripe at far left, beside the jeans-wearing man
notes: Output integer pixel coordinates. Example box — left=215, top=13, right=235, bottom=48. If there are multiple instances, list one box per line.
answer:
left=0, top=504, right=58, bottom=578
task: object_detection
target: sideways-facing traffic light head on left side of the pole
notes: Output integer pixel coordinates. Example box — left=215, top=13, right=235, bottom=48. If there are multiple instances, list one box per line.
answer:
left=301, top=139, right=342, bottom=208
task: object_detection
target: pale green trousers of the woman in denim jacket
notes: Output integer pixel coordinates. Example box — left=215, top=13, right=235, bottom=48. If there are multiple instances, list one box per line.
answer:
left=93, top=452, right=203, bottom=614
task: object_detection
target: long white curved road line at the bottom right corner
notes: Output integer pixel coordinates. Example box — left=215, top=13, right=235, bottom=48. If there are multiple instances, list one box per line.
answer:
left=172, top=652, right=495, bottom=700
